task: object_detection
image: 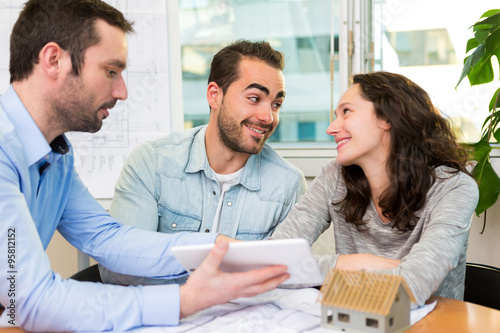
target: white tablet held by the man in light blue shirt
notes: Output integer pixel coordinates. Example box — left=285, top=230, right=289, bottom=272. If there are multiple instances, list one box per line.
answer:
left=171, top=238, right=323, bottom=288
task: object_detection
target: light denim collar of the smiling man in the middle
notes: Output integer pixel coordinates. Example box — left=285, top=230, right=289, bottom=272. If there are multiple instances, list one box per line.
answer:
left=185, top=125, right=261, bottom=191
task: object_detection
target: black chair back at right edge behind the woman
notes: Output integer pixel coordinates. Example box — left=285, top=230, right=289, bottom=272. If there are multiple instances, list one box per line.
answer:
left=464, top=263, right=500, bottom=310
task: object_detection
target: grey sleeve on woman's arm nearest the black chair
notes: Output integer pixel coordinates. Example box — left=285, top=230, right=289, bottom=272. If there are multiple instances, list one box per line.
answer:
left=382, top=174, right=479, bottom=305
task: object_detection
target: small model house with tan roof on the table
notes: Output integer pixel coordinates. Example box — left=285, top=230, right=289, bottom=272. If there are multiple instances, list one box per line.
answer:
left=320, top=269, right=414, bottom=333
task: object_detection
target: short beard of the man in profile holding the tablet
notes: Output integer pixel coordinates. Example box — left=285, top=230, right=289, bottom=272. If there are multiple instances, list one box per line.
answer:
left=51, top=74, right=117, bottom=133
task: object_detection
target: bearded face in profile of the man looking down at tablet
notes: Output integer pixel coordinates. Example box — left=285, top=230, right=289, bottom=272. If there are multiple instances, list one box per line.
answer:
left=52, top=20, right=128, bottom=133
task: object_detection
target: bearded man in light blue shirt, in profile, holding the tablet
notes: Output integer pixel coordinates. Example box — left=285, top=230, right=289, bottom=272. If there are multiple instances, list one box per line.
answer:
left=0, top=0, right=288, bottom=331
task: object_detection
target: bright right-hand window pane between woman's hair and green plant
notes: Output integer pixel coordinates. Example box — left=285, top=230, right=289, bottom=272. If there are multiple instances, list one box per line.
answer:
left=373, top=0, right=498, bottom=142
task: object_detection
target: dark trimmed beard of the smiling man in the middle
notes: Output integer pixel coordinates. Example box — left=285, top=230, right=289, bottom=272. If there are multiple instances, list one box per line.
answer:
left=217, top=100, right=275, bottom=155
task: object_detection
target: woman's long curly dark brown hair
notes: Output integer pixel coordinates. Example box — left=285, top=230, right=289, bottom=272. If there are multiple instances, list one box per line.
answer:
left=333, top=72, right=470, bottom=232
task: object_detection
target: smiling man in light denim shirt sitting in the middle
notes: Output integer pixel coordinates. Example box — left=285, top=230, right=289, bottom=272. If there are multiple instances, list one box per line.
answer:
left=100, top=40, right=306, bottom=284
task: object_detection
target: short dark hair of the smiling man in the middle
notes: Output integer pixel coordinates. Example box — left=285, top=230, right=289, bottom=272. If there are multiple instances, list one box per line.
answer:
left=208, top=40, right=285, bottom=93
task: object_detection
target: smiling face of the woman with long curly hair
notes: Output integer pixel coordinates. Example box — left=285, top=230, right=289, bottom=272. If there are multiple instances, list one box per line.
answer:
left=326, top=84, right=390, bottom=170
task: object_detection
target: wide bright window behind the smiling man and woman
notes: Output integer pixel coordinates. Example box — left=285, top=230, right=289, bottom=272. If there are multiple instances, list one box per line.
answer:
left=179, top=0, right=498, bottom=147
